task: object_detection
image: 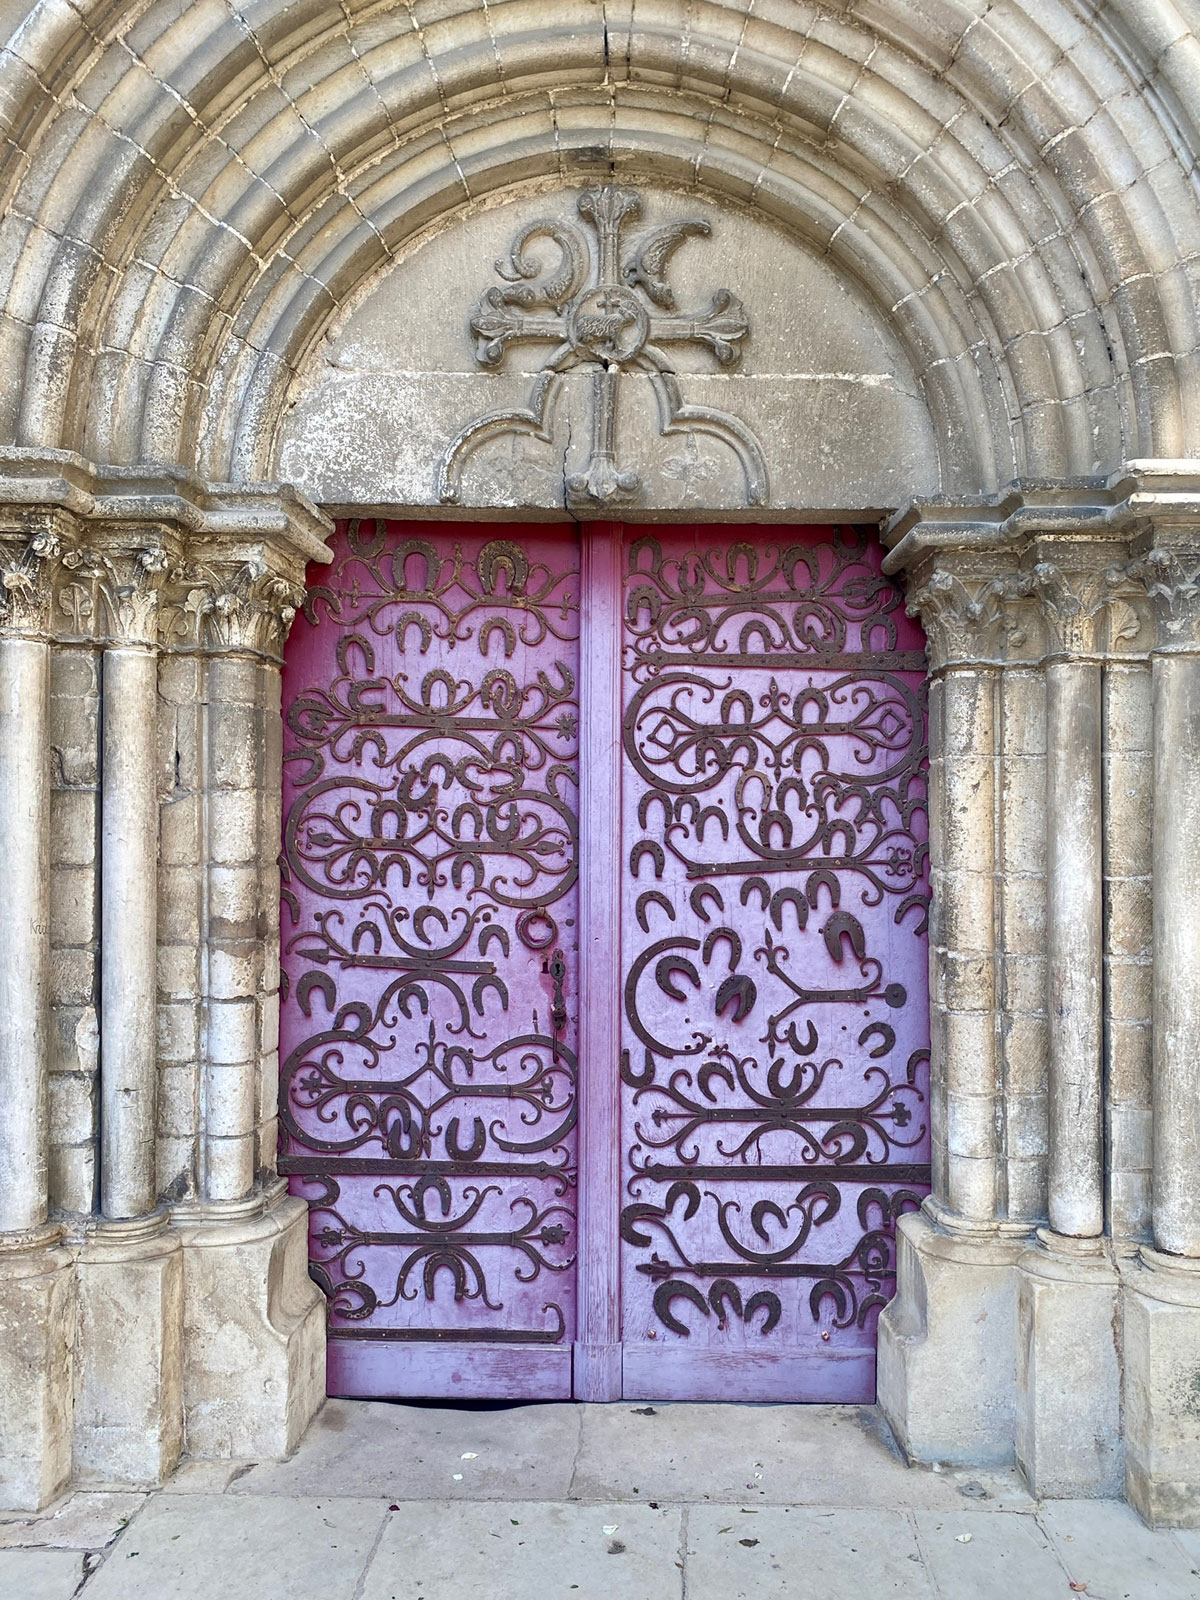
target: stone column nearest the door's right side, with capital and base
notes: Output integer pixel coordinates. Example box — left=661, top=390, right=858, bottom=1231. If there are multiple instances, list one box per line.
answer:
left=878, top=547, right=1029, bottom=1464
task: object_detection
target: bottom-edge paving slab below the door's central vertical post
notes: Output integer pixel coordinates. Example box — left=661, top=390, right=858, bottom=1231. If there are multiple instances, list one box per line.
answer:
left=356, top=1501, right=683, bottom=1600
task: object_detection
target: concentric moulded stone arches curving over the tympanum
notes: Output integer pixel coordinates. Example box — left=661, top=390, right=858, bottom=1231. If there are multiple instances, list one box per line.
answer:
left=0, top=0, right=1200, bottom=488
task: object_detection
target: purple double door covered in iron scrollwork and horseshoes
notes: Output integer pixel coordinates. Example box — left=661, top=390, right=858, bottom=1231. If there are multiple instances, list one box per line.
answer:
left=280, top=520, right=930, bottom=1400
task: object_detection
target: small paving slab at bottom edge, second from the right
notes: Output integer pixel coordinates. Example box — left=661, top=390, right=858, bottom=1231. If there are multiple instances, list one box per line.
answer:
left=914, top=1510, right=1070, bottom=1600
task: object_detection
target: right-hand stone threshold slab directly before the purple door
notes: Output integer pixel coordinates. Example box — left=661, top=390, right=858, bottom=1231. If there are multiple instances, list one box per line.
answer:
left=571, top=1403, right=1034, bottom=1510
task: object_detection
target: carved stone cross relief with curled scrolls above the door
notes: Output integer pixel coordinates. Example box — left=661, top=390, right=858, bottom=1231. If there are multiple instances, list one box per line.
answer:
left=438, top=186, right=766, bottom=506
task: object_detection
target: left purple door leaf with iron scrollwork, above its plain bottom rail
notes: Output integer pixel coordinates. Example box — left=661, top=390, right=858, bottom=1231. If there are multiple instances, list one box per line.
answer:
left=280, top=522, right=579, bottom=1344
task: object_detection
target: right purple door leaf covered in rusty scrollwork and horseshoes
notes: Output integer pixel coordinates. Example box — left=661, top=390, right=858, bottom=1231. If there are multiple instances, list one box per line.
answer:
left=621, top=528, right=930, bottom=1398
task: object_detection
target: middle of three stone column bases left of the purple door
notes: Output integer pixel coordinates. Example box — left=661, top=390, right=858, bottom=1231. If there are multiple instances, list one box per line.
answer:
left=75, top=1214, right=184, bottom=1486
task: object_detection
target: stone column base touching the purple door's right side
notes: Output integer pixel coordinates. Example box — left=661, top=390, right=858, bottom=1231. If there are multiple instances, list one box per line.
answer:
left=878, top=1202, right=1027, bottom=1467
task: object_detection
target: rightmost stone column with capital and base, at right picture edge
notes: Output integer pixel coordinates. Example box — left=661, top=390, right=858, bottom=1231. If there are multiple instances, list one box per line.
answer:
left=1125, top=528, right=1200, bottom=1526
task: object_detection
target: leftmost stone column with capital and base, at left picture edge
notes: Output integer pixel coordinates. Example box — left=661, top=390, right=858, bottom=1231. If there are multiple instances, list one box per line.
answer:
left=0, top=528, right=74, bottom=1510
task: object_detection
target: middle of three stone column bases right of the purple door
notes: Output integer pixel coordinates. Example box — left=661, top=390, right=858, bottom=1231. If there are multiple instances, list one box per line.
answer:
left=1016, top=1229, right=1125, bottom=1499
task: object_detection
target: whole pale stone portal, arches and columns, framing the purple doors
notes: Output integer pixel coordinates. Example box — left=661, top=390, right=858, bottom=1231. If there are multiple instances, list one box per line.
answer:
left=0, top=0, right=1200, bottom=1523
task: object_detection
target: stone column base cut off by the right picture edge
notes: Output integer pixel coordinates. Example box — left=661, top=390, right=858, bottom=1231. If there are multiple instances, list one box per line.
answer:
left=1125, top=1246, right=1200, bottom=1528
